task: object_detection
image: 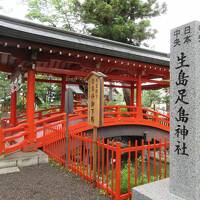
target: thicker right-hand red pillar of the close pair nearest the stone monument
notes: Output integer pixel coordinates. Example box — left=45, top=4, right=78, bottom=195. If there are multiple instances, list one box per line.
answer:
left=136, top=75, right=142, bottom=118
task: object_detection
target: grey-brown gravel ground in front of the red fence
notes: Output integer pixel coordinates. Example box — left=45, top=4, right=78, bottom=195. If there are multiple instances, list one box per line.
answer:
left=0, top=164, right=109, bottom=200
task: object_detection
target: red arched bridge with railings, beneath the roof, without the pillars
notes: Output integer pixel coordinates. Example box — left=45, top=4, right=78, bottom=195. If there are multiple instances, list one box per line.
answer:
left=1, top=106, right=169, bottom=154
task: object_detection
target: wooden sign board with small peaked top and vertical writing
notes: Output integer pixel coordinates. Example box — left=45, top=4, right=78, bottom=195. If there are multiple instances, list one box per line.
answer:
left=87, top=72, right=106, bottom=127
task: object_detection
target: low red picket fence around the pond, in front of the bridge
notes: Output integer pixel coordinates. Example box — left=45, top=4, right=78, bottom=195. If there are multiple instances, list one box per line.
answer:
left=44, top=123, right=169, bottom=200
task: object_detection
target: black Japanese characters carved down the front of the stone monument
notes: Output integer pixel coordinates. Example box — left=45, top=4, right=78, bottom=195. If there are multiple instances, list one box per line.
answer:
left=172, top=25, right=192, bottom=156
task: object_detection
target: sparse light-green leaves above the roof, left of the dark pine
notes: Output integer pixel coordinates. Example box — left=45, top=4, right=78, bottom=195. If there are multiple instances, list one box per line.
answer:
left=25, top=0, right=79, bottom=31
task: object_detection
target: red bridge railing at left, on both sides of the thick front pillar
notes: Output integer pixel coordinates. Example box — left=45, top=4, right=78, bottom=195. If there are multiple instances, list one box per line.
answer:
left=0, top=113, right=66, bottom=155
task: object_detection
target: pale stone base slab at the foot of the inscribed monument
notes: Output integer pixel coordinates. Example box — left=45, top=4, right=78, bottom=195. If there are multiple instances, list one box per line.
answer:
left=132, top=178, right=185, bottom=200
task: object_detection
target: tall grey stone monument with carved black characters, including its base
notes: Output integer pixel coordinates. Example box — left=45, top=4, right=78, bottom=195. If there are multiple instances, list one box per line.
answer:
left=133, top=21, right=200, bottom=200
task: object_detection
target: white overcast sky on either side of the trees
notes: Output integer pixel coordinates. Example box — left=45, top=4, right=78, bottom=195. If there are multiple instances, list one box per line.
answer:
left=0, top=0, right=200, bottom=53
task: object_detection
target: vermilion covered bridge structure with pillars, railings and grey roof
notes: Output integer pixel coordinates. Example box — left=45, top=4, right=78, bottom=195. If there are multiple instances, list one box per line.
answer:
left=0, top=16, right=169, bottom=154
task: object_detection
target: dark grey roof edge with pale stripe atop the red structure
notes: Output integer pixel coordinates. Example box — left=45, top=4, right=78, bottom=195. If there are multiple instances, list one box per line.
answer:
left=0, top=15, right=169, bottom=67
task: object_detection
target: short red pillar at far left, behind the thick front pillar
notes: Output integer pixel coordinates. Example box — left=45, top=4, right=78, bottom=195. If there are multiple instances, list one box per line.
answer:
left=10, top=91, right=17, bottom=126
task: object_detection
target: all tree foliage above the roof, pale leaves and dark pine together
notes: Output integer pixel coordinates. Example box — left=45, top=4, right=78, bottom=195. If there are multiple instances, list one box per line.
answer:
left=25, top=0, right=166, bottom=46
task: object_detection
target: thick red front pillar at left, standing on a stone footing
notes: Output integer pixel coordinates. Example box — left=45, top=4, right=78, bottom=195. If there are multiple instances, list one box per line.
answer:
left=24, top=69, right=37, bottom=151
